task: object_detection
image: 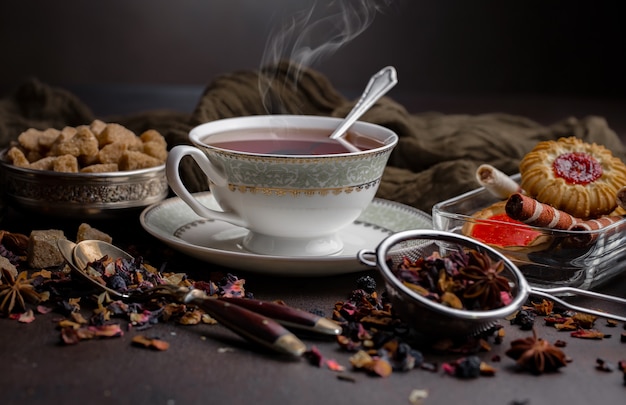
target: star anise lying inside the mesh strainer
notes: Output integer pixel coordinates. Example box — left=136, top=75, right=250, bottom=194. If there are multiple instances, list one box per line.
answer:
left=459, top=250, right=511, bottom=309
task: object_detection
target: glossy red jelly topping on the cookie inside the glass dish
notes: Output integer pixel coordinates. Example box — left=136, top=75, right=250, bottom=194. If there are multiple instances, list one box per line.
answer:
left=471, top=213, right=541, bottom=247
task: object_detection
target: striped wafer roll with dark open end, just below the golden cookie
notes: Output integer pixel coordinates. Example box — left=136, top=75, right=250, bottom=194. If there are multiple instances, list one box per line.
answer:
left=505, top=193, right=579, bottom=230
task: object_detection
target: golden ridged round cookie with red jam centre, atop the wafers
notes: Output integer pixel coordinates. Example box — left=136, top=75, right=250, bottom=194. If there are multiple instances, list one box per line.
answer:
left=519, top=137, right=626, bottom=219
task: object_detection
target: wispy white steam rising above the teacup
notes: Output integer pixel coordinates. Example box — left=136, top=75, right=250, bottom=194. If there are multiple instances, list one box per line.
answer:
left=259, top=0, right=393, bottom=111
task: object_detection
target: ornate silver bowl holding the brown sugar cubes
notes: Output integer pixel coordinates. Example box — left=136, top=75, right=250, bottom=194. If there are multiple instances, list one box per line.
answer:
left=0, top=150, right=169, bottom=219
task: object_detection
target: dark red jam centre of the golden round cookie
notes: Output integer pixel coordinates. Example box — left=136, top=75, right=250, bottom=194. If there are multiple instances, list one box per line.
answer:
left=552, top=152, right=602, bottom=186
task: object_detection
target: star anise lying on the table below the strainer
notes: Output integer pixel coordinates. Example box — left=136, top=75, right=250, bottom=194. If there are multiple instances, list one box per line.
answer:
left=506, top=329, right=567, bottom=374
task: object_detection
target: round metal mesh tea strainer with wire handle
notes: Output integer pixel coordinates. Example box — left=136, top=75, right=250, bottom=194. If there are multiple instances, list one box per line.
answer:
left=357, top=230, right=626, bottom=338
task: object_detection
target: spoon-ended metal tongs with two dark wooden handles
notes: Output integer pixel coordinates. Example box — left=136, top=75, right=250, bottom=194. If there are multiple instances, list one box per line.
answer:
left=57, top=239, right=342, bottom=356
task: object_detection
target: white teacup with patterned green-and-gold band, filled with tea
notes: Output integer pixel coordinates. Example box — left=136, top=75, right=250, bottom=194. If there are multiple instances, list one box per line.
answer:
left=166, top=115, right=398, bottom=256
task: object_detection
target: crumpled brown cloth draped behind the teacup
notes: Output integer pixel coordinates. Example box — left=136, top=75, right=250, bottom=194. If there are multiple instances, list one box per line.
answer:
left=0, top=62, right=626, bottom=212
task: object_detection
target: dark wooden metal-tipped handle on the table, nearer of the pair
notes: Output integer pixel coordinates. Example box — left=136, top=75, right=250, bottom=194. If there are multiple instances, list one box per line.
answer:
left=184, top=290, right=306, bottom=356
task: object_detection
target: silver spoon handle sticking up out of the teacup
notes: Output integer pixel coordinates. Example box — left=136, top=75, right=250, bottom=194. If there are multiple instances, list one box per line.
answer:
left=330, top=66, right=398, bottom=139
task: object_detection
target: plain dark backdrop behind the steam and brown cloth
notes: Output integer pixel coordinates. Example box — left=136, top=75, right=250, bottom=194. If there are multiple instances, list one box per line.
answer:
left=0, top=0, right=626, bottom=110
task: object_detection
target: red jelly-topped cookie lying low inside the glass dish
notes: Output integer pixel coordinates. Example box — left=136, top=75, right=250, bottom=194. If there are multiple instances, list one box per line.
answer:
left=461, top=201, right=551, bottom=251
